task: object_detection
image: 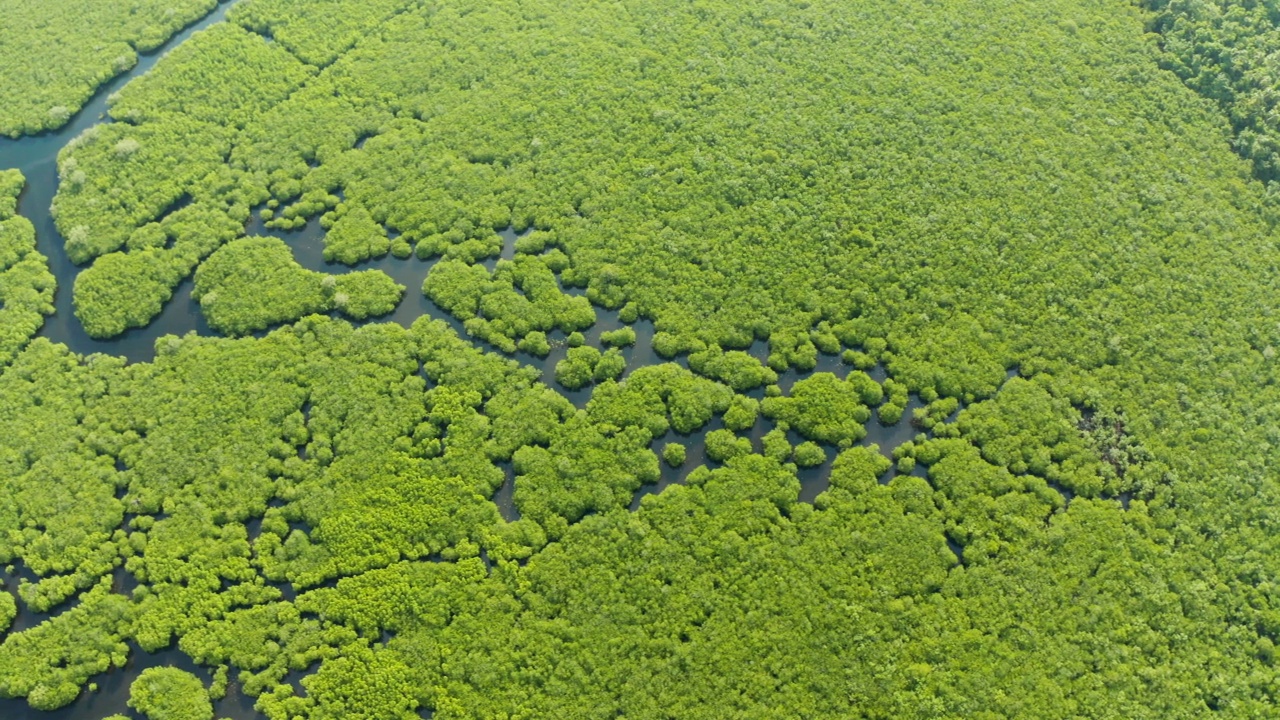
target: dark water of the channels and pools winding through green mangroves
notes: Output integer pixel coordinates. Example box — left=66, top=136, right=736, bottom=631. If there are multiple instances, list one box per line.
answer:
left=0, top=0, right=942, bottom=707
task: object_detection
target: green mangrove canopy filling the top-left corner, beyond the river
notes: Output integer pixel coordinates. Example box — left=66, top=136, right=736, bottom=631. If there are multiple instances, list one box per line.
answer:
left=0, top=0, right=219, bottom=137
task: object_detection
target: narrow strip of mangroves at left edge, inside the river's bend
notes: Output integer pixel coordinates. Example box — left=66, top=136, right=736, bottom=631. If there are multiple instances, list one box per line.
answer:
left=0, top=170, right=58, bottom=368
